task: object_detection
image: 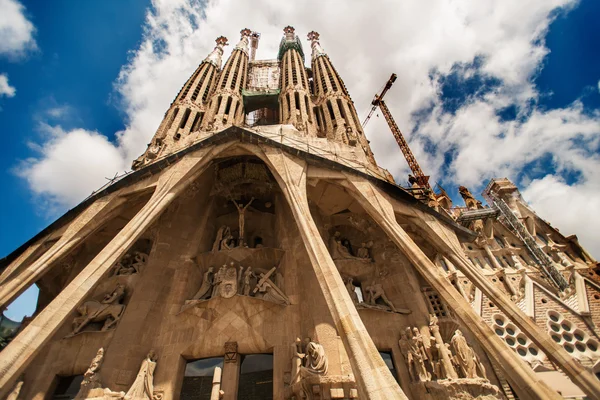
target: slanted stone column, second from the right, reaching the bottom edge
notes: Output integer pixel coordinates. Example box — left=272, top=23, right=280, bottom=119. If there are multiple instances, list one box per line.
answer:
left=342, top=175, right=562, bottom=400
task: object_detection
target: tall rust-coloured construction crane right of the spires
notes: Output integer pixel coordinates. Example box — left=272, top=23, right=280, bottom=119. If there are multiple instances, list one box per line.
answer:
left=362, top=74, right=432, bottom=190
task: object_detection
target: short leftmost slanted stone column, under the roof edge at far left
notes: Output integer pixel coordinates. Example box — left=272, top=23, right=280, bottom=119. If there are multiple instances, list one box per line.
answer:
left=0, top=196, right=124, bottom=309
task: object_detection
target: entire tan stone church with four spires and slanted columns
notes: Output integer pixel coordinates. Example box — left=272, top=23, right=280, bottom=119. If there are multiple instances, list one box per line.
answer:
left=0, top=26, right=600, bottom=400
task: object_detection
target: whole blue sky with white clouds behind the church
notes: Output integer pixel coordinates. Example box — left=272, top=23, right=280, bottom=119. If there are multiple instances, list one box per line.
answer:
left=0, top=0, right=600, bottom=318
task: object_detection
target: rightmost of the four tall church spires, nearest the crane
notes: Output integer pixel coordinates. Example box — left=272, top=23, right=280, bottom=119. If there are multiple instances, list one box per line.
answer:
left=308, top=31, right=375, bottom=164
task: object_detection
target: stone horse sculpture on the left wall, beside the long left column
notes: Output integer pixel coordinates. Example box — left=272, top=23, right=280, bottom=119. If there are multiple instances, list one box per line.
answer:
left=70, top=284, right=125, bottom=336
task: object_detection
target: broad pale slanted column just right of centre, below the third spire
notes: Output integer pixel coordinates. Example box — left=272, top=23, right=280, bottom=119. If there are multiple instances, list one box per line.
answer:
left=264, top=149, right=407, bottom=400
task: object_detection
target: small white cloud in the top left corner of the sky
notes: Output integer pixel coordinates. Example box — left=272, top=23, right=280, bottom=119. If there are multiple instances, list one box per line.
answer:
left=0, top=0, right=37, bottom=58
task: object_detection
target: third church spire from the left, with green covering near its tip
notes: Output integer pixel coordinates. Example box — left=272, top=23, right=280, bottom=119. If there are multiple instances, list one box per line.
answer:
left=278, top=26, right=317, bottom=136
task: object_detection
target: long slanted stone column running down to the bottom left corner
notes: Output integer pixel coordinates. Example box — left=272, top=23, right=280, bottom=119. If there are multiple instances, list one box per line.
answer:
left=0, top=150, right=216, bottom=398
